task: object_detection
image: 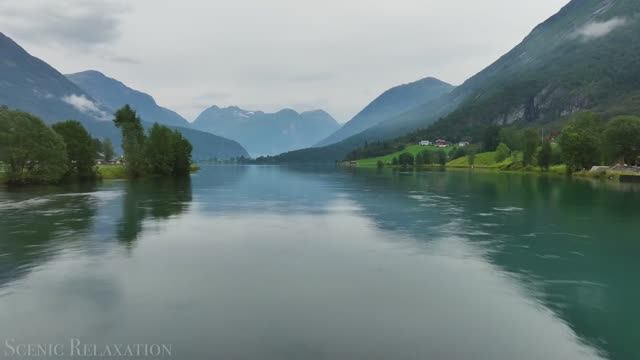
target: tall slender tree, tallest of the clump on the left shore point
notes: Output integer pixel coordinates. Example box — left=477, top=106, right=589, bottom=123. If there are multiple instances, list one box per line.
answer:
left=113, top=105, right=147, bottom=177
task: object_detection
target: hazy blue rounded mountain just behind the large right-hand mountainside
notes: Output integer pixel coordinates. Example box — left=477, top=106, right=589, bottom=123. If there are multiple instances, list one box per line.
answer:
left=317, top=77, right=454, bottom=147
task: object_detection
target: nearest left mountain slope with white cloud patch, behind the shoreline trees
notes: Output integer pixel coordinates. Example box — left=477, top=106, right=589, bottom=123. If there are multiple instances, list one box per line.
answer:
left=0, top=33, right=248, bottom=160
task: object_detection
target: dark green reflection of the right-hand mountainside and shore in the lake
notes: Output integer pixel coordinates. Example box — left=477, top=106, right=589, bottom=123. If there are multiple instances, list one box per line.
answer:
left=340, top=171, right=640, bottom=359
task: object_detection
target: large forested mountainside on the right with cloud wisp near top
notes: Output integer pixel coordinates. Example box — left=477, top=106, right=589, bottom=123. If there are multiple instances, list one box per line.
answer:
left=273, top=0, right=640, bottom=162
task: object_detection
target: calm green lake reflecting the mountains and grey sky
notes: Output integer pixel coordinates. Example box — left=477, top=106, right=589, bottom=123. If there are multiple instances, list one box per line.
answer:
left=0, top=166, right=640, bottom=360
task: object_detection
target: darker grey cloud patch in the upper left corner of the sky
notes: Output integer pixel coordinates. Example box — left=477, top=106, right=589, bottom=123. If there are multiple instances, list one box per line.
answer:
left=0, top=0, right=127, bottom=49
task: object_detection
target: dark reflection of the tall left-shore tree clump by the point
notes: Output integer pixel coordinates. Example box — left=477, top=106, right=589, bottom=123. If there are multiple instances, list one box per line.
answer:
left=117, top=177, right=192, bottom=246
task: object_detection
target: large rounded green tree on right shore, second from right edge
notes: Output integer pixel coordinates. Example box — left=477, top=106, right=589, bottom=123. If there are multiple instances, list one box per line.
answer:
left=560, top=112, right=600, bottom=172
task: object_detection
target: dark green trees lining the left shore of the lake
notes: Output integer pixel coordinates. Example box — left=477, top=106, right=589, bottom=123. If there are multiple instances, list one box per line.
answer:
left=0, top=106, right=192, bottom=185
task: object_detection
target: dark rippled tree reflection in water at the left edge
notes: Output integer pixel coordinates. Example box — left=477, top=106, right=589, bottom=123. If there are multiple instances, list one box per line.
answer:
left=0, top=184, right=97, bottom=286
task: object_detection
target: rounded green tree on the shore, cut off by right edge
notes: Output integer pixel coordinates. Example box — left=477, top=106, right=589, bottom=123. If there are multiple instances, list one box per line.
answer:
left=604, top=116, right=640, bottom=165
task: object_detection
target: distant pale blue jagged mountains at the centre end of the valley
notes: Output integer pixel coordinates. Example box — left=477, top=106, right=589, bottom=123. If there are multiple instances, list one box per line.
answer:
left=192, top=106, right=340, bottom=156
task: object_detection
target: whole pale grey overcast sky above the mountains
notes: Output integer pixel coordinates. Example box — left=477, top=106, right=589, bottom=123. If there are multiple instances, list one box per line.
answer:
left=0, top=0, right=568, bottom=122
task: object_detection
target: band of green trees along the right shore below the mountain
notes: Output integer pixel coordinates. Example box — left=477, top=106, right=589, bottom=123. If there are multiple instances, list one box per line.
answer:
left=376, top=112, right=640, bottom=173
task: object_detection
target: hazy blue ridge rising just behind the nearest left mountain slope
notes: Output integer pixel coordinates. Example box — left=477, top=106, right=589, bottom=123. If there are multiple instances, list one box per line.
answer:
left=66, top=70, right=189, bottom=127
